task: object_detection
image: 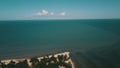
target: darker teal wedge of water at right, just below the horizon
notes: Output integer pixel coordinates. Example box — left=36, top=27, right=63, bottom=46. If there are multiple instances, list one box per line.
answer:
left=87, top=19, right=120, bottom=36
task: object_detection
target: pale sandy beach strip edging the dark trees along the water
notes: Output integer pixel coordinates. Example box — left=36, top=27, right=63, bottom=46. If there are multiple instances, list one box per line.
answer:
left=1, top=52, right=75, bottom=68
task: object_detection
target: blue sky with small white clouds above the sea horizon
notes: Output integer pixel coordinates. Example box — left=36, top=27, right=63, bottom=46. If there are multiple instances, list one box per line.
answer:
left=0, top=0, right=120, bottom=20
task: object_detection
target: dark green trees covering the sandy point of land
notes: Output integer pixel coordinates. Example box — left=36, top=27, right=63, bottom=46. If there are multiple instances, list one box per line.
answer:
left=0, top=54, right=72, bottom=68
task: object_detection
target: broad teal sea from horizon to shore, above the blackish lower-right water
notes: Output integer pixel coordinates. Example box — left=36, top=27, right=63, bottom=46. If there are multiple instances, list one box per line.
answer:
left=0, top=19, right=120, bottom=59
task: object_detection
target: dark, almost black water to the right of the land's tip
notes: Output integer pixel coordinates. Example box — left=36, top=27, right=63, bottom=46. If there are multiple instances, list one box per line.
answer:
left=72, top=42, right=120, bottom=68
